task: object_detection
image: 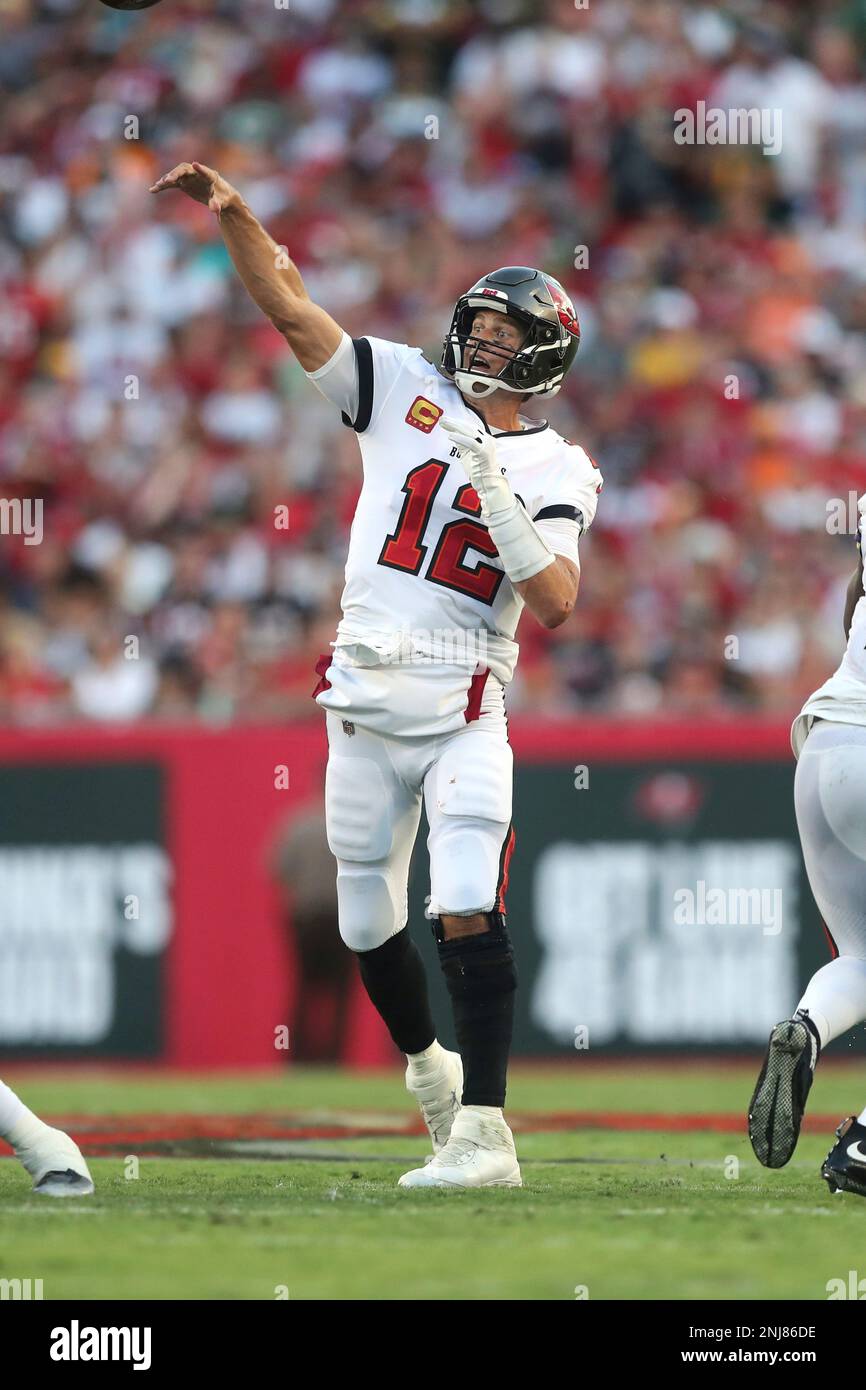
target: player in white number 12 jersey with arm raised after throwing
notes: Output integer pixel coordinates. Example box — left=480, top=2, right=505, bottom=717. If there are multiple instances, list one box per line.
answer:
left=153, top=163, right=602, bottom=1187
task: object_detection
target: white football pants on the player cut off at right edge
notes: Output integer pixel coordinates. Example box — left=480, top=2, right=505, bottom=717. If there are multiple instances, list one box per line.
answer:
left=794, top=719, right=866, bottom=1045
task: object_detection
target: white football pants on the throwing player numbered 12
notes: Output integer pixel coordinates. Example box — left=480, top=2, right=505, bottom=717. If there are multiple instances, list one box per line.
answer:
left=325, top=703, right=514, bottom=951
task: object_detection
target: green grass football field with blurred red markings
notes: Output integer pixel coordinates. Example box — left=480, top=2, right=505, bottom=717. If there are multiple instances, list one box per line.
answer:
left=0, top=1058, right=866, bottom=1300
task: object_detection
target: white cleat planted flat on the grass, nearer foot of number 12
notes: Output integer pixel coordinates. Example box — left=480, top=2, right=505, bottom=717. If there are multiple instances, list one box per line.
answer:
left=398, top=1105, right=523, bottom=1187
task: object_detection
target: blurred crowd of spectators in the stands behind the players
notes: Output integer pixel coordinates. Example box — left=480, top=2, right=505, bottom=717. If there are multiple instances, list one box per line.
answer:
left=0, top=0, right=866, bottom=724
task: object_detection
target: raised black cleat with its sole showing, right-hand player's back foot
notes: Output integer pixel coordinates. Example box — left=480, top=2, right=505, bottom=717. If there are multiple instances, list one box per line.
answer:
left=749, top=1013, right=822, bottom=1168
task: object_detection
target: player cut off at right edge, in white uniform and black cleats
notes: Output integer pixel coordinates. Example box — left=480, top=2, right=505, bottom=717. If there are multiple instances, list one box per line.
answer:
left=749, top=496, right=866, bottom=1197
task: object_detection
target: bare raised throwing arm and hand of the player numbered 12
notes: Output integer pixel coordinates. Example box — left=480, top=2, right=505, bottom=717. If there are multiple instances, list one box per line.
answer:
left=150, top=161, right=343, bottom=371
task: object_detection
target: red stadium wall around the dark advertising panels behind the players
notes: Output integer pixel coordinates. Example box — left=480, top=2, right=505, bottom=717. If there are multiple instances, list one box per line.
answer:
left=0, top=719, right=791, bottom=1068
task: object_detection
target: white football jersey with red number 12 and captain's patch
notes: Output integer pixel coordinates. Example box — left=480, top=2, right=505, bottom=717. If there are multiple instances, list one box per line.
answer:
left=309, top=335, right=602, bottom=734
